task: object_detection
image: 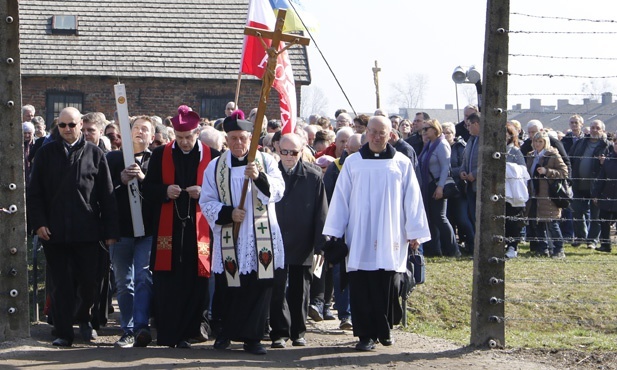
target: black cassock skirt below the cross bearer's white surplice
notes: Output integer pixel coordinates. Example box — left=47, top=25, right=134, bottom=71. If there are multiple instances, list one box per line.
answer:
left=215, top=270, right=274, bottom=342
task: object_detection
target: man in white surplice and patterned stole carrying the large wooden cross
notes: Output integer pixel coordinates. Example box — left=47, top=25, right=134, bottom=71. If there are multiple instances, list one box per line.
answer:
left=199, top=111, right=285, bottom=354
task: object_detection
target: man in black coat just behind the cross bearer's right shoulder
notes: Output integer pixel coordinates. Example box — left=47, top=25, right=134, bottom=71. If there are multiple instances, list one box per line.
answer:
left=270, top=134, right=328, bottom=348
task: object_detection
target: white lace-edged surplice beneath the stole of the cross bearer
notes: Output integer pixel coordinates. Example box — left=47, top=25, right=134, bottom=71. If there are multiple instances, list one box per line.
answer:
left=199, top=150, right=285, bottom=274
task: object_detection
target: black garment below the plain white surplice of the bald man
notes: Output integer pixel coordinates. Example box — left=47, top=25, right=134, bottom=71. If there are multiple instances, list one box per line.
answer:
left=349, top=270, right=398, bottom=340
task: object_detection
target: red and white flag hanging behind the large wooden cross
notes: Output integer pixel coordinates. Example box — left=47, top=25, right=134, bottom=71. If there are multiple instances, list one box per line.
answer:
left=240, top=0, right=297, bottom=134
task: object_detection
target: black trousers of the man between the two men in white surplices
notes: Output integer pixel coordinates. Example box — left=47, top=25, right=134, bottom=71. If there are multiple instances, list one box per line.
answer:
left=270, top=265, right=311, bottom=341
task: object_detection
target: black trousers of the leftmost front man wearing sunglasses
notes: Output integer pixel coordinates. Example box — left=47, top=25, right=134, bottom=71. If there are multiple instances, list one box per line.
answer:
left=43, top=242, right=101, bottom=343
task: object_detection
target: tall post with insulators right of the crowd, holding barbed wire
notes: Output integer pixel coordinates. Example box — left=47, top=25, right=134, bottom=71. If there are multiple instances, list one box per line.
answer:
left=470, top=0, right=510, bottom=348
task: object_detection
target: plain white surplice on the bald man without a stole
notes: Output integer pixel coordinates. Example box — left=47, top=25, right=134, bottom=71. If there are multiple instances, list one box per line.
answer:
left=323, top=152, right=431, bottom=272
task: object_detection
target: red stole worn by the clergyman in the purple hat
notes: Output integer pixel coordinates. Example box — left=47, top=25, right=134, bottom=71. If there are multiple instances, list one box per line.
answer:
left=154, top=141, right=212, bottom=277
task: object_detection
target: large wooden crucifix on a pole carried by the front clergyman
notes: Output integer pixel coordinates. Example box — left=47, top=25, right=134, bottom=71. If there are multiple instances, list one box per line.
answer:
left=233, top=9, right=310, bottom=242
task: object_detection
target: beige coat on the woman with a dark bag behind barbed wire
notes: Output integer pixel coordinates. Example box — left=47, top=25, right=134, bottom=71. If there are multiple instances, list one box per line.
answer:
left=527, top=148, right=568, bottom=220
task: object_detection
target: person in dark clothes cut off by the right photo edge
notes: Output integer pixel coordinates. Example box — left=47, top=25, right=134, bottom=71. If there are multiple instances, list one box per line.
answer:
left=591, top=137, right=617, bottom=253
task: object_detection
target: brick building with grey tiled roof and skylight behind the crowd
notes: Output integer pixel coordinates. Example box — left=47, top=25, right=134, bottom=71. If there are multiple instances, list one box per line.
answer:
left=20, top=0, right=310, bottom=123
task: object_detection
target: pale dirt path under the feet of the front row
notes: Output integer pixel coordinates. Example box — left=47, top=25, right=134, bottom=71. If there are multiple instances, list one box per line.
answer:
left=0, top=313, right=617, bottom=370
